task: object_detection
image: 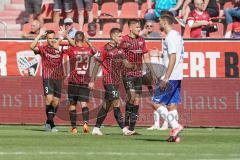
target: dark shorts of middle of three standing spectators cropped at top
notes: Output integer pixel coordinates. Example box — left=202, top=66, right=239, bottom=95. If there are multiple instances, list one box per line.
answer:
left=53, top=0, right=73, bottom=12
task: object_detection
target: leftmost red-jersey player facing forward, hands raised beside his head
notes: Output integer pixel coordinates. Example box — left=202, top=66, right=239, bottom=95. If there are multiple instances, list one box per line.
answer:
left=30, top=29, right=64, bottom=132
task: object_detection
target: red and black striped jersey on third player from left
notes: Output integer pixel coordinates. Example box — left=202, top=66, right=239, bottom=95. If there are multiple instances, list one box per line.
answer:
left=100, top=43, right=124, bottom=85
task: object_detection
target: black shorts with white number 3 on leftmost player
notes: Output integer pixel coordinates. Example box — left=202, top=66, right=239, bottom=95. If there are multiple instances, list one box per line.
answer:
left=43, top=79, right=62, bottom=98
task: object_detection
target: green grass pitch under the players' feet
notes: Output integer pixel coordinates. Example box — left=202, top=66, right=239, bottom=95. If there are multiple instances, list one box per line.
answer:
left=0, top=125, right=240, bottom=160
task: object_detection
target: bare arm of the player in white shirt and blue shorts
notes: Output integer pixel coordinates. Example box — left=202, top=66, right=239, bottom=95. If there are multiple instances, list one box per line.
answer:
left=160, top=53, right=176, bottom=90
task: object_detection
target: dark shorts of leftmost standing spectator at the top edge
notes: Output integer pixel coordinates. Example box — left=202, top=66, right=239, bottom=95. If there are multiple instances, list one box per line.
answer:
left=24, top=0, right=42, bottom=14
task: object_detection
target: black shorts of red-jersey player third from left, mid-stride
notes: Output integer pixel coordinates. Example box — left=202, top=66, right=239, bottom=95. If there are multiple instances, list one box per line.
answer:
left=104, top=84, right=120, bottom=101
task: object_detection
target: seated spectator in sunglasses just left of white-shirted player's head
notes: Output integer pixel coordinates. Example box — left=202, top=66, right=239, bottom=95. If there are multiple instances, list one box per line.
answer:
left=140, top=21, right=161, bottom=38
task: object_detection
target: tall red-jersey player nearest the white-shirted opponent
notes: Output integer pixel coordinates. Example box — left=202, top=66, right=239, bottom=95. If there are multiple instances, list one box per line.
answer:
left=121, top=20, right=156, bottom=134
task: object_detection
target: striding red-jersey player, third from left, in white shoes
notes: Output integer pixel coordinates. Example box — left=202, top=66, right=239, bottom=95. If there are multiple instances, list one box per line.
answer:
left=90, top=28, right=136, bottom=135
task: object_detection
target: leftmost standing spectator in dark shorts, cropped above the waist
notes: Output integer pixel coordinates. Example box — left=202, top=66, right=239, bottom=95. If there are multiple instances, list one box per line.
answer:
left=24, top=0, right=43, bottom=25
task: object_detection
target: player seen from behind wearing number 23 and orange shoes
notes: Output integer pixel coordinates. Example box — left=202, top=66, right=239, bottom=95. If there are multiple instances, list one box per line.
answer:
left=65, top=31, right=95, bottom=134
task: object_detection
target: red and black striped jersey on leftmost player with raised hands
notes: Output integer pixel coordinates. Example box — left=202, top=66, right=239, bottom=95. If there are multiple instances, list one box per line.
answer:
left=38, top=45, right=64, bottom=79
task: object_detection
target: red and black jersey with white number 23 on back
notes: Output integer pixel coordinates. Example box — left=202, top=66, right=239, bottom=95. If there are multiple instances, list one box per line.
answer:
left=65, top=46, right=94, bottom=84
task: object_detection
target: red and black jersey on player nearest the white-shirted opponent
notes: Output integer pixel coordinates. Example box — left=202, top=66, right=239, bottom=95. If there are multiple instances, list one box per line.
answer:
left=121, top=35, right=148, bottom=77
